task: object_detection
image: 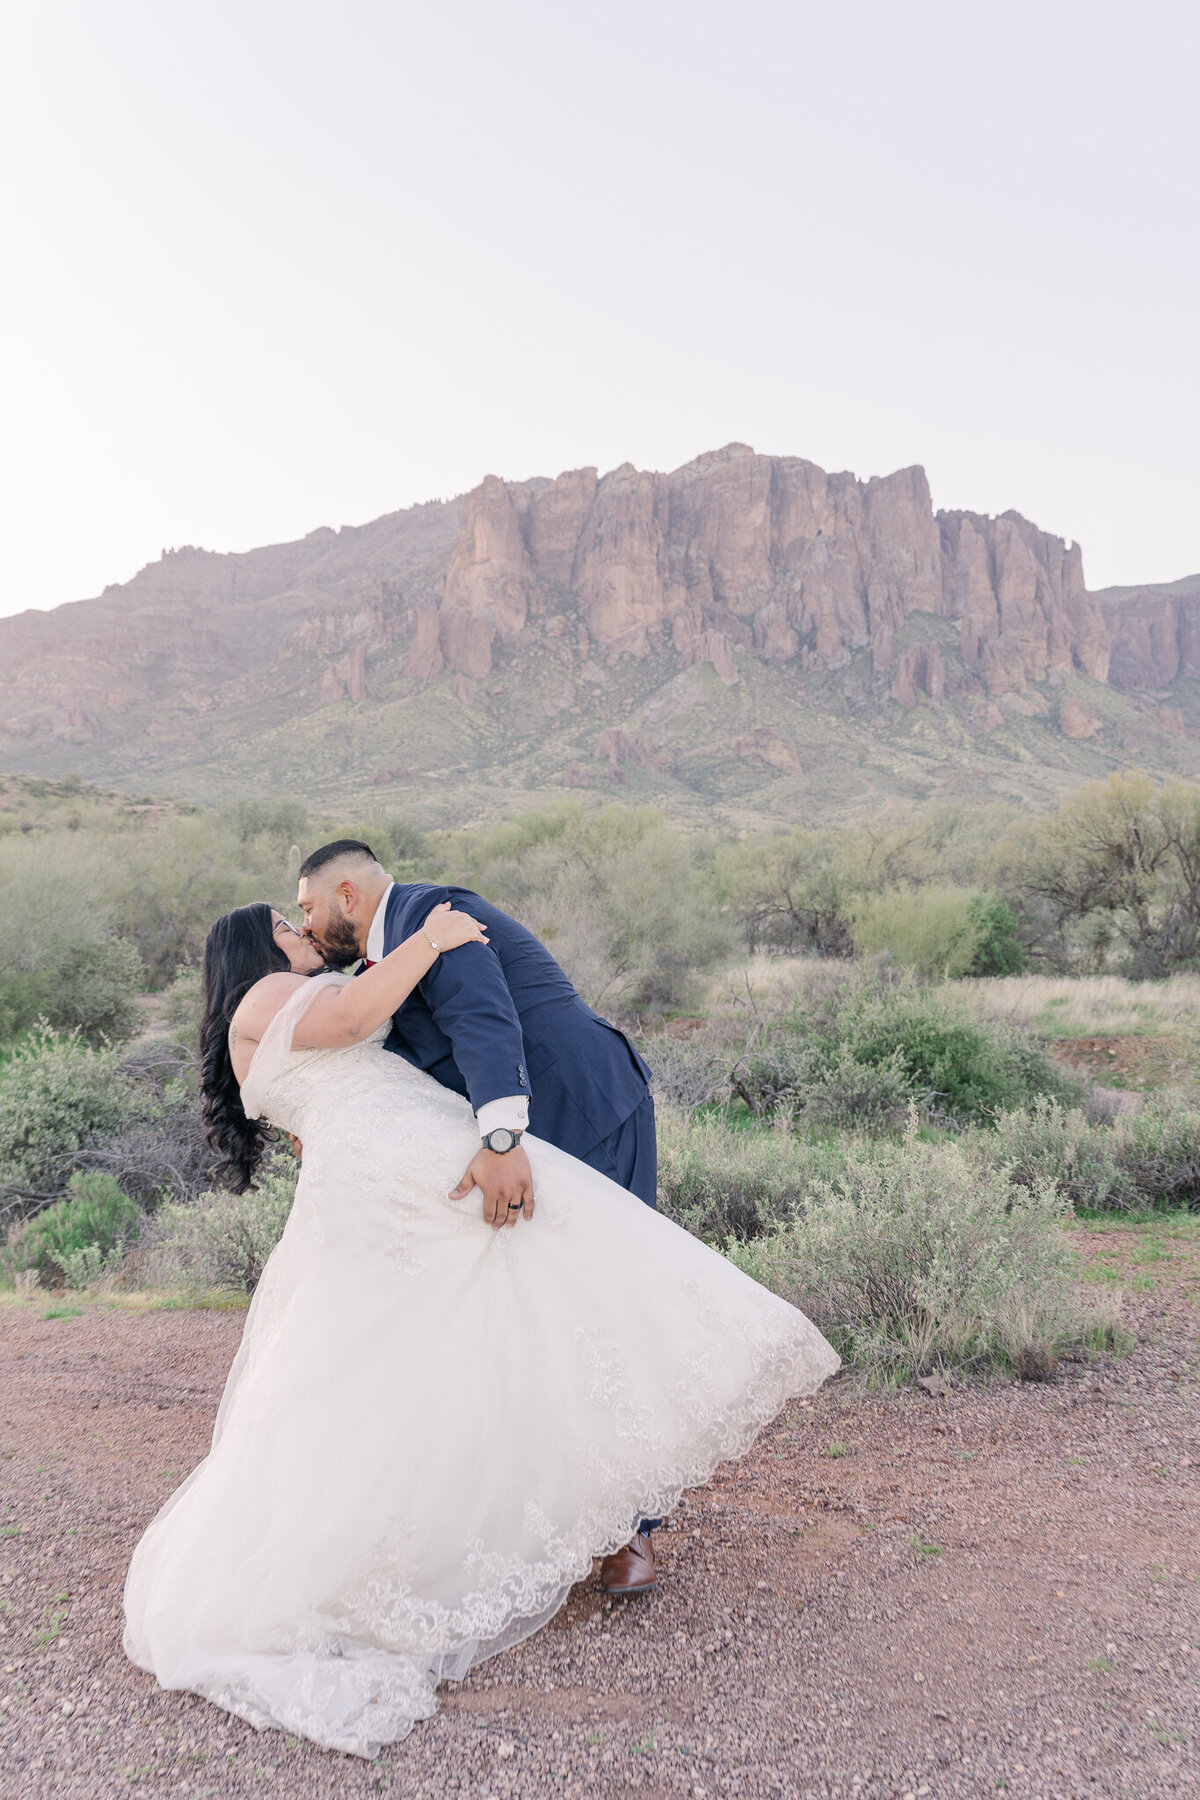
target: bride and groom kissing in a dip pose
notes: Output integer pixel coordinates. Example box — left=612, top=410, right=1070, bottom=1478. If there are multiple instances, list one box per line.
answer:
left=124, top=839, right=838, bottom=1755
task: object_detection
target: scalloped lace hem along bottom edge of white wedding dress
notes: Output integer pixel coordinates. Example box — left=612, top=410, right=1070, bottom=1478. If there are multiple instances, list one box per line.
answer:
left=126, top=1339, right=838, bottom=1759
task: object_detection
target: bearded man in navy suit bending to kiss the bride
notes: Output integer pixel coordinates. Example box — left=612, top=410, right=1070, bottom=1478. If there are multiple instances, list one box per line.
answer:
left=297, top=837, right=658, bottom=1593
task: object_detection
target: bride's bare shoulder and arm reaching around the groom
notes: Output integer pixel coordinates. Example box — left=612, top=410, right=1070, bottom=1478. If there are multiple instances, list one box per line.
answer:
left=230, top=900, right=488, bottom=1073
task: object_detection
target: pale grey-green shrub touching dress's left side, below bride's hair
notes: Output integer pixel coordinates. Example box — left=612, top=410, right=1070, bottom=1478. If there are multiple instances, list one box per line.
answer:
left=144, top=1150, right=299, bottom=1294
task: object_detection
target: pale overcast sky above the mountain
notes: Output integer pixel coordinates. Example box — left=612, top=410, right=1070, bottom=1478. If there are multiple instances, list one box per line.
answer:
left=0, top=0, right=1200, bottom=612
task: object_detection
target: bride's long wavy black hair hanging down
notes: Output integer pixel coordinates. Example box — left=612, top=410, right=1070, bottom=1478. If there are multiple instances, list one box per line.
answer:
left=200, top=900, right=291, bottom=1193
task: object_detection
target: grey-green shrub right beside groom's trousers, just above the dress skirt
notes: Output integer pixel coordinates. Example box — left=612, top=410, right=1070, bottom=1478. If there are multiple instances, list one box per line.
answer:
left=658, top=1107, right=840, bottom=1244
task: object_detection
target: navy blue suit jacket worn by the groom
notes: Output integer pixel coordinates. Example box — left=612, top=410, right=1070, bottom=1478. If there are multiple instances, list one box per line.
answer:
left=383, top=882, right=649, bottom=1157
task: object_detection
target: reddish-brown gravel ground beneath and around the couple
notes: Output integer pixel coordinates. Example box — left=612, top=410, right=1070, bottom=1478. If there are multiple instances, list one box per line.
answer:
left=0, top=1228, right=1200, bottom=1800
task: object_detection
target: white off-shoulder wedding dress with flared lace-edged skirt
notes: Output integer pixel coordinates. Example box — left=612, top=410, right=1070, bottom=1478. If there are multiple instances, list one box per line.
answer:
left=124, top=976, right=838, bottom=1757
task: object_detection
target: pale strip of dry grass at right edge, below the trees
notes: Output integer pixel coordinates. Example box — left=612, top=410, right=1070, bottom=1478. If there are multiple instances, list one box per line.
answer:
left=955, top=976, right=1200, bottom=1037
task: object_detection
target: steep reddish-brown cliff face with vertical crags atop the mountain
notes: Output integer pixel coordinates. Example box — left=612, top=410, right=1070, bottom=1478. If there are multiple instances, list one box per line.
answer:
left=412, top=445, right=1108, bottom=693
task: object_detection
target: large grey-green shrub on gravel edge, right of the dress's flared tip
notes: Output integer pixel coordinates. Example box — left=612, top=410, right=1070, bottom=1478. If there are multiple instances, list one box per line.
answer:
left=729, top=1130, right=1108, bottom=1381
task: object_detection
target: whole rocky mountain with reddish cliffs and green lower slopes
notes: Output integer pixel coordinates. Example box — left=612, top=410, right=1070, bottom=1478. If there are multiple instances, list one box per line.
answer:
left=0, top=445, right=1200, bottom=821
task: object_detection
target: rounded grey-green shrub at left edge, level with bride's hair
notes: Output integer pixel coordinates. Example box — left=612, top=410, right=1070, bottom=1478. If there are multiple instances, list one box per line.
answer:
left=0, top=1026, right=131, bottom=1204
